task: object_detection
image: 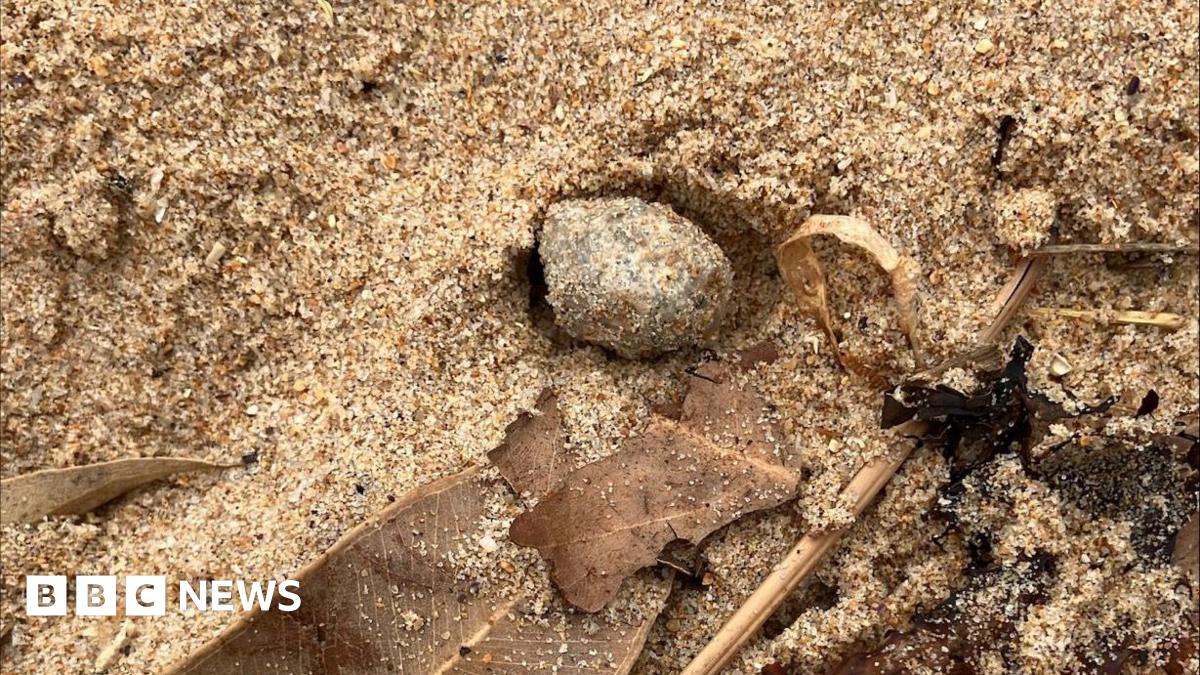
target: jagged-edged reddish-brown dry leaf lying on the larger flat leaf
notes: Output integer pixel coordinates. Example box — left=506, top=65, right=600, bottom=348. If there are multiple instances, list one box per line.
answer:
left=509, top=364, right=799, bottom=611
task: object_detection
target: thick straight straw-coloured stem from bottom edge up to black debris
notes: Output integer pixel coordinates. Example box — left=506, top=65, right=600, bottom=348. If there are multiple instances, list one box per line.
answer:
left=683, top=422, right=925, bottom=675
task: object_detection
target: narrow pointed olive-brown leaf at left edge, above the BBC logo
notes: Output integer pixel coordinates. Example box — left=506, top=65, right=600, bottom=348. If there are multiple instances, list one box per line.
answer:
left=0, top=458, right=235, bottom=525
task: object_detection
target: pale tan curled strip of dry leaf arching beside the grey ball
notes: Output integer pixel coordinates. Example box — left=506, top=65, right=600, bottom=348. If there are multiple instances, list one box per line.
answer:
left=776, top=215, right=924, bottom=368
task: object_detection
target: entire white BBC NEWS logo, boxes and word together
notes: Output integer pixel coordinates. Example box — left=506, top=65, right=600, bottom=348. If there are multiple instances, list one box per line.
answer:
left=25, top=574, right=300, bottom=616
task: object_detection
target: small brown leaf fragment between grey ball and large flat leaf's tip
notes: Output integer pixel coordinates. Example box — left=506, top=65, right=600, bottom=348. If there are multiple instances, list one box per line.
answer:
left=487, top=389, right=574, bottom=496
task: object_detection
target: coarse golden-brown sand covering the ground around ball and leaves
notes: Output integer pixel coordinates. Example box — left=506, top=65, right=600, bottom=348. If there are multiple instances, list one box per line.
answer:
left=0, top=0, right=1200, bottom=674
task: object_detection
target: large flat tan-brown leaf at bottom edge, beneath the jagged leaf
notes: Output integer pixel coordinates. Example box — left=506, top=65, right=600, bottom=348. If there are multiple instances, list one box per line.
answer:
left=169, top=468, right=670, bottom=675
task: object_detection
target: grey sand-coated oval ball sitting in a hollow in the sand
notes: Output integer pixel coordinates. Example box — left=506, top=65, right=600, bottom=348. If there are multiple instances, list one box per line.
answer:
left=539, top=198, right=733, bottom=358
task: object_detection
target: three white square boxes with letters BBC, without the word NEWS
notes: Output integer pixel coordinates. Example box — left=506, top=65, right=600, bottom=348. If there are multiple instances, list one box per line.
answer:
left=25, top=574, right=167, bottom=616
